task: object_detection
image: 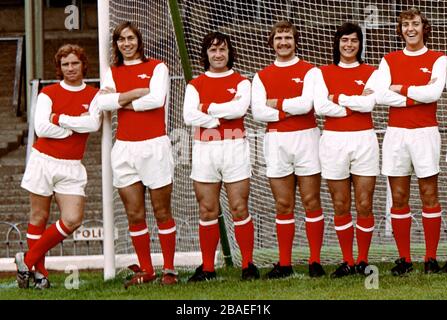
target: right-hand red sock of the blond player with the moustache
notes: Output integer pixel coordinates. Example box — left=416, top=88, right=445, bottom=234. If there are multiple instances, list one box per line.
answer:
left=305, top=209, right=324, bottom=264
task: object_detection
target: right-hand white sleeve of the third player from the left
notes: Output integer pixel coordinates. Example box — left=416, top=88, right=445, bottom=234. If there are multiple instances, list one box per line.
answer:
left=208, top=79, right=251, bottom=120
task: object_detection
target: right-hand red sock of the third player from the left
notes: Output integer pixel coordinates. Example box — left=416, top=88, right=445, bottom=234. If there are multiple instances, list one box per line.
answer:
left=233, top=215, right=255, bottom=269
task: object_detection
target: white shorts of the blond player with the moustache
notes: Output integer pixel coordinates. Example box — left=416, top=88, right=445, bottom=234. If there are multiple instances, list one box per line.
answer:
left=264, top=128, right=321, bottom=178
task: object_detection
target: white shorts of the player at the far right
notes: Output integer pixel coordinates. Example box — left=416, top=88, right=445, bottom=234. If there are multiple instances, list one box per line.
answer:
left=382, top=127, right=441, bottom=178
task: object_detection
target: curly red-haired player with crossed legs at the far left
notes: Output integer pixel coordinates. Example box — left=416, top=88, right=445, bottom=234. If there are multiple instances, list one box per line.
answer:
left=15, top=44, right=102, bottom=289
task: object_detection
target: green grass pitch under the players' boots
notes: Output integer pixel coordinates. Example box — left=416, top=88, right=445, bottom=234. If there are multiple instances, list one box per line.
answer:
left=0, top=263, right=447, bottom=300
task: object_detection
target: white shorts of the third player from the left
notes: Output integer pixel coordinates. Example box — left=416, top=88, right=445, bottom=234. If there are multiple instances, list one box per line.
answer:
left=191, top=139, right=251, bottom=183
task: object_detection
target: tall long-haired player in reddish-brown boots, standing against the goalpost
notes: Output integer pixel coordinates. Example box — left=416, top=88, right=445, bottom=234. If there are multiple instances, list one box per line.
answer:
left=98, top=22, right=178, bottom=288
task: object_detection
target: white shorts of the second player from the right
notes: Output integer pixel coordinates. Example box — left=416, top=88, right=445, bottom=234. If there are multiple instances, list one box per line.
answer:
left=320, top=129, right=380, bottom=180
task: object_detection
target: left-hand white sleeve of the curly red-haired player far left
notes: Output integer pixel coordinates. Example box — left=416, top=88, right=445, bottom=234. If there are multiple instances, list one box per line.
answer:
left=34, top=93, right=73, bottom=139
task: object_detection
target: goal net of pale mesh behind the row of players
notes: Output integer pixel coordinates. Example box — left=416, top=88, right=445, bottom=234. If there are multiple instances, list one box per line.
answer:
left=109, top=0, right=447, bottom=266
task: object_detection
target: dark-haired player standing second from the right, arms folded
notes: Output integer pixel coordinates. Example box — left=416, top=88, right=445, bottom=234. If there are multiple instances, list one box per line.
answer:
left=314, top=22, right=380, bottom=278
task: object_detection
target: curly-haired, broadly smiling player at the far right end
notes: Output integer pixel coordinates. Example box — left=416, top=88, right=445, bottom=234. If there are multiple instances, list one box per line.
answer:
left=376, top=8, right=447, bottom=275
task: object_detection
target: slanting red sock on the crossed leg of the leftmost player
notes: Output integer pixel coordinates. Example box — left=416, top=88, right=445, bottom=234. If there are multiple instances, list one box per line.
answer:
left=25, top=220, right=71, bottom=270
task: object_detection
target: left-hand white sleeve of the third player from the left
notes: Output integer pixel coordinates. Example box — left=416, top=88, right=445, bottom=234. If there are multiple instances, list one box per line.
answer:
left=183, top=84, right=220, bottom=129
